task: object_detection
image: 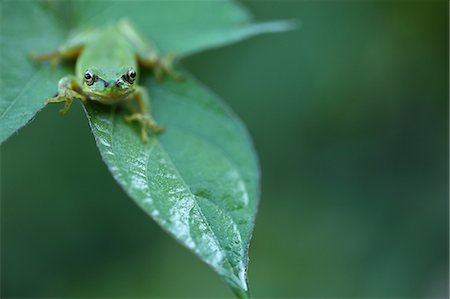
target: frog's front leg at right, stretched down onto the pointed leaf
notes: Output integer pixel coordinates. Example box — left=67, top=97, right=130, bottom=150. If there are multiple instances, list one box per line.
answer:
left=125, top=86, right=164, bottom=143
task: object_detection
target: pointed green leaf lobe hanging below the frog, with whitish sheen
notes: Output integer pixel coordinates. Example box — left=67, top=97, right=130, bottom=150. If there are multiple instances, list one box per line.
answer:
left=85, top=74, right=259, bottom=298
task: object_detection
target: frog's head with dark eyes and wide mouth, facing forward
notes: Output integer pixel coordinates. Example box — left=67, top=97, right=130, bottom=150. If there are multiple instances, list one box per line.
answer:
left=83, top=67, right=137, bottom=99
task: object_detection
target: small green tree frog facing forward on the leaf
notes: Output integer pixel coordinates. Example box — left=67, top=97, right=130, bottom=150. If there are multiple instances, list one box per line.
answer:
left=31, top=20, right=181, bottom=143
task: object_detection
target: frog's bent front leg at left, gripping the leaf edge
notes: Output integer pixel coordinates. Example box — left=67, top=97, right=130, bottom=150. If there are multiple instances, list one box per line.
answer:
left=45, top=76, right=87, bottom=114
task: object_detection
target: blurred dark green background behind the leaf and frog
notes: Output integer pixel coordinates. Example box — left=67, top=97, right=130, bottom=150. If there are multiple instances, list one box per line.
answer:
left=1, top=1, right=449, bottom=298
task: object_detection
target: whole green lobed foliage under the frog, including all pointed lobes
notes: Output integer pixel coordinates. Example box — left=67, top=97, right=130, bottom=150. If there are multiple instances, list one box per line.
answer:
left=0, top=1, right=290, bottom=298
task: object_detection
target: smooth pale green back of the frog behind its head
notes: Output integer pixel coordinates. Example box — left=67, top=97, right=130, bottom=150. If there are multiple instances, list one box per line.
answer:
left=76, top=25, right=137, bottom=78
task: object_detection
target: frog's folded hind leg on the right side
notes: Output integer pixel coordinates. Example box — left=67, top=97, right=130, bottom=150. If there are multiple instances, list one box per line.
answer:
left=118, top=19, right=183, bottom=80
